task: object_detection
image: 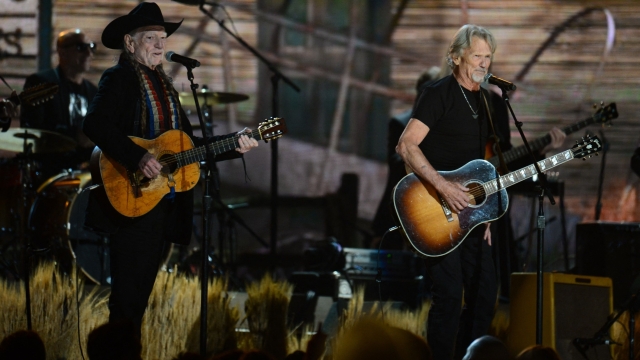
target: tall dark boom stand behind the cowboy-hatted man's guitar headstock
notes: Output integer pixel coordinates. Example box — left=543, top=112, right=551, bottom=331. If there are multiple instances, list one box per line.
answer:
left=200, top=0, right=300, bottom=266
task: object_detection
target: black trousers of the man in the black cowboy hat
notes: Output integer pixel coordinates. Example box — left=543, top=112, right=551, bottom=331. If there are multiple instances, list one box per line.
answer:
left=109, top=199, right=173, bottom=336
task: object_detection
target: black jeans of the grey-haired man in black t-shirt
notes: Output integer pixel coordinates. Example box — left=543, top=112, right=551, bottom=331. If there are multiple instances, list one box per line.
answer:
left=426, top=229, right=498, bottom=360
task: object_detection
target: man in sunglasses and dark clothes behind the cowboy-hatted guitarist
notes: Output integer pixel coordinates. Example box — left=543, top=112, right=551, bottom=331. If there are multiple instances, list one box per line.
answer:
left=20, top=29, right=98, bottom=179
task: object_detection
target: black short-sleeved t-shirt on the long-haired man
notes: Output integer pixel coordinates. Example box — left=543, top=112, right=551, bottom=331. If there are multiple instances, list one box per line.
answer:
left=412, top=75, right=489, bottom=171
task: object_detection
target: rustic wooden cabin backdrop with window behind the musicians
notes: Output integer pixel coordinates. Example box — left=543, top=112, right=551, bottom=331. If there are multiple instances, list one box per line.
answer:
left=0, top=0, right=640, bottom=270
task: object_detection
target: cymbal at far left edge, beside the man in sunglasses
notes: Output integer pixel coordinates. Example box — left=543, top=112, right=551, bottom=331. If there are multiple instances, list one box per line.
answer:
left=0, top=128, right=76, bottom=154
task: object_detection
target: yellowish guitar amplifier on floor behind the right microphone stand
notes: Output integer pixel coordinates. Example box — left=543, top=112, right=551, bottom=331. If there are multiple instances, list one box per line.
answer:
left=507, top=273, right=613, bottom=360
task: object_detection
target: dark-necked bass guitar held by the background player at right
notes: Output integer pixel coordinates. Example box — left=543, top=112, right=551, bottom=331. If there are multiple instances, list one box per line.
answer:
left=484, top=103, right=618, bottom=169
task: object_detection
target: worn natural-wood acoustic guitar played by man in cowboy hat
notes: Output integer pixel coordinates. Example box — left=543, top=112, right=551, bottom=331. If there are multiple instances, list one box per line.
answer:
left=90, top=118, right=287, bottom=217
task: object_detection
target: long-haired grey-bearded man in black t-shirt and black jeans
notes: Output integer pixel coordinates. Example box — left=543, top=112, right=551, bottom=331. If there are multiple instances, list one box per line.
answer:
left=396, top=25, right=497, bottom=359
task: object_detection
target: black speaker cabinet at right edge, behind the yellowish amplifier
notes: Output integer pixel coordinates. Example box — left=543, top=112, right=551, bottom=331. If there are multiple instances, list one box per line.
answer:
left=575, top=221, right=640, bottom=308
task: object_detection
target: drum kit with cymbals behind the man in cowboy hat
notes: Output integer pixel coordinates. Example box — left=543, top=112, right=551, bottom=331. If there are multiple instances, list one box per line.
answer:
left=0, top=89, right=248, bottom=285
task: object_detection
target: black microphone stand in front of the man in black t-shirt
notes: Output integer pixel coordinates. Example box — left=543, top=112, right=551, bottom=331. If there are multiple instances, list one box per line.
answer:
left=498, top=86, right=556, bottom=345
